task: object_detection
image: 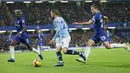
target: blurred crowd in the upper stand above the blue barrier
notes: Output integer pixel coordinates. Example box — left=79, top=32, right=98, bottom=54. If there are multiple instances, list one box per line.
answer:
left=0, top=2, right=130, bottom=26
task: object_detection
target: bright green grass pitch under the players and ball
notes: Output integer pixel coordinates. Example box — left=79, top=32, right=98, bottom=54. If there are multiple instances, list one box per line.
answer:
left=0, top=49, right=130, bottom=73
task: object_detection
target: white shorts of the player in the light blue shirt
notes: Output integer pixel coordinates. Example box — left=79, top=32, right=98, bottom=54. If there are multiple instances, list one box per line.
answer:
left=56, top=36, right=71, bottom=48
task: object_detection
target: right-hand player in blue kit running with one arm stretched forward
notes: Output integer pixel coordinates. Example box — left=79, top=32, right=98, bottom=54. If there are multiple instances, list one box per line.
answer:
left=73, top=4, right=130, bottom=63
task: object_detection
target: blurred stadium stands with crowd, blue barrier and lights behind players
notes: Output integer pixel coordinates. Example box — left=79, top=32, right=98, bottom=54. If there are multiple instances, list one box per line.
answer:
left=0, top=0, right=130, bottom=52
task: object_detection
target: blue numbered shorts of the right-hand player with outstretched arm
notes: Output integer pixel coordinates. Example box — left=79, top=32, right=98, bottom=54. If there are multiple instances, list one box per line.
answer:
left=92, top=34, right=109, bottom=43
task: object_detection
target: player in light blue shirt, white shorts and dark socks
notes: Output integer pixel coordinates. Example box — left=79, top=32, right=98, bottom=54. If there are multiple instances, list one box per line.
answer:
left=49, top=10, right=86, bottom=67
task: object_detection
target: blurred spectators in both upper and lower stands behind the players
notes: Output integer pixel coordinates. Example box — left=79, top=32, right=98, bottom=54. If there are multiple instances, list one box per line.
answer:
left=0, top=2, right=130, bottom=51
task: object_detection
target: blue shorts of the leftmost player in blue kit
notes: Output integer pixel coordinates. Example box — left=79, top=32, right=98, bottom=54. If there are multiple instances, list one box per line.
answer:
left=14, top=35, right=30, bottom=44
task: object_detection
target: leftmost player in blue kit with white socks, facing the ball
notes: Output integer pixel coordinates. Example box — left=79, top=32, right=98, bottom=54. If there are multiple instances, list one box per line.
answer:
left=8, top=10, right=43, bottom=62
